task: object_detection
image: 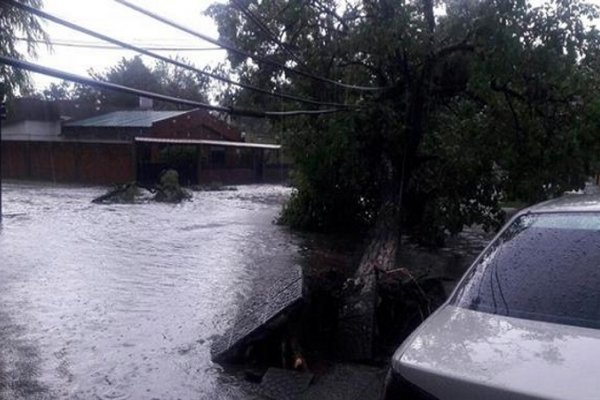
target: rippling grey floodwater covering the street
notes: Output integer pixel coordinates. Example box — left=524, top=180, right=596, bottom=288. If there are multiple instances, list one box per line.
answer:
left=0, top=183, right=299, bottom=400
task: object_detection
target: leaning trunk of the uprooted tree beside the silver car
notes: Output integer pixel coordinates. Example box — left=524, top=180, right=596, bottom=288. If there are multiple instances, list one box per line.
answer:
left=337, top=0, right=436, bottom=361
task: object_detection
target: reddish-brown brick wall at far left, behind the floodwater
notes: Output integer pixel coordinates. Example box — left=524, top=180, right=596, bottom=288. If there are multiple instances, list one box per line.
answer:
left=2, top=141, right=135, bottom=185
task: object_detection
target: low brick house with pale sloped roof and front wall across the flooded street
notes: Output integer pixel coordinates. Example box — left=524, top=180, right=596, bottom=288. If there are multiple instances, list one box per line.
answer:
left=2, top=99, right=283, bottom=184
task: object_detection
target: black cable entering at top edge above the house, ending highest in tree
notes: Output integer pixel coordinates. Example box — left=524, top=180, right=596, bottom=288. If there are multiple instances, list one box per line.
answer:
left=114, top=0, right=386, bottom=91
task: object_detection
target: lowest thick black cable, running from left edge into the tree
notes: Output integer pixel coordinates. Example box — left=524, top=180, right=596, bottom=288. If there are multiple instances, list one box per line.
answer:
left=0, top=55, right=345, bottom=118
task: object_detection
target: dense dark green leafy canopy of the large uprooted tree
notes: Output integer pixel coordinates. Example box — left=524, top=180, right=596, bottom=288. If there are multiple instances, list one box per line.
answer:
left=210, top=0, right=600, bottom=244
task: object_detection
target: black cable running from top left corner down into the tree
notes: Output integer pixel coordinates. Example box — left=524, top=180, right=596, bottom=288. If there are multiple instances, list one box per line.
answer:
left=3, top=0, right=347, bottom=107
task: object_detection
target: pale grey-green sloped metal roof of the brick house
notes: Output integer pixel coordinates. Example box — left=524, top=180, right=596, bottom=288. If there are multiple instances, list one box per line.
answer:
left=65, top=110, right=189, bottom=128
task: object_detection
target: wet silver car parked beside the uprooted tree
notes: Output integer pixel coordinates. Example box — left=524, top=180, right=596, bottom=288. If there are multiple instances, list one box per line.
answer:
left=384, top=195, right=600, bottom=400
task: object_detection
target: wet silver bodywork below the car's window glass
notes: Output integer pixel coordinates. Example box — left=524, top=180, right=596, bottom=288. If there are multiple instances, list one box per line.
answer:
left=392, top=306, right=600, bottom=400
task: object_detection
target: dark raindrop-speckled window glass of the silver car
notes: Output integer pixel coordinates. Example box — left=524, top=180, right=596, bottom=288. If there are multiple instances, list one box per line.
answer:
left=452, top=213, right=600, bottom=328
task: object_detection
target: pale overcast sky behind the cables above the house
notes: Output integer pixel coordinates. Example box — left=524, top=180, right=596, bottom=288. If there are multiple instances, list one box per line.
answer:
left=25, top=0, right=225, bottom=89
